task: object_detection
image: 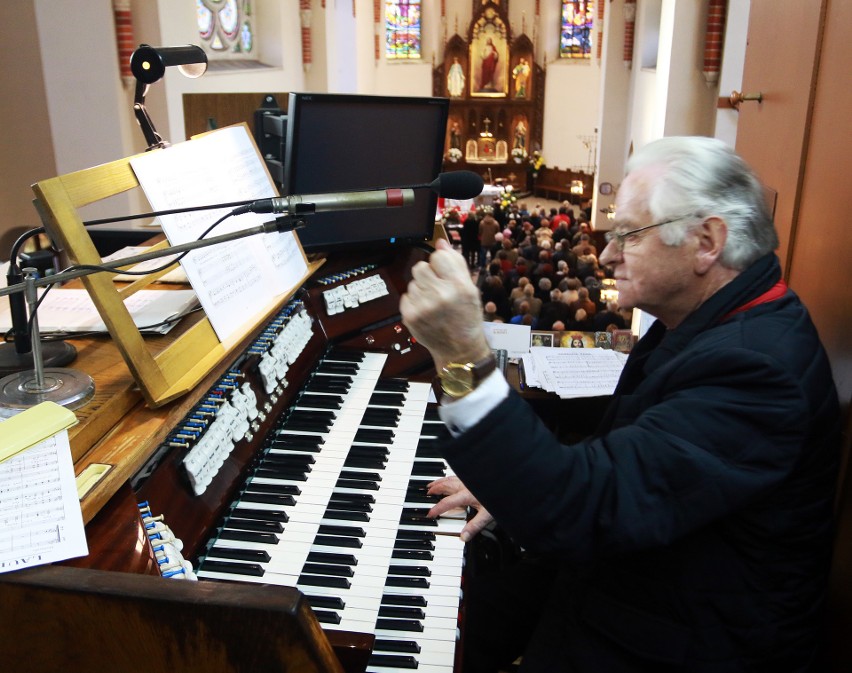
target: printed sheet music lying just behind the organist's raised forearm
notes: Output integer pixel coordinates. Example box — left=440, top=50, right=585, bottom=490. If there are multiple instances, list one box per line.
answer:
left=524, top=346, right=627, bottom=399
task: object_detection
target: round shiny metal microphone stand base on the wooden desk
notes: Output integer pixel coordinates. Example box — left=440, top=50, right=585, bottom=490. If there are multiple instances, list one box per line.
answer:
left=0, top=367, right=95, bottom=410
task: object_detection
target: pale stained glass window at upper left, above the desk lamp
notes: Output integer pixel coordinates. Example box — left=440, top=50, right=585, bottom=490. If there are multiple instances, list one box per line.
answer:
left=195, top=0, right=255, bottom=59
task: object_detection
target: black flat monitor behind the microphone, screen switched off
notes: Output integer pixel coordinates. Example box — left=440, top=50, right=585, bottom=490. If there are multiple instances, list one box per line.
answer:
left=282, top=93, right=449, bottom=252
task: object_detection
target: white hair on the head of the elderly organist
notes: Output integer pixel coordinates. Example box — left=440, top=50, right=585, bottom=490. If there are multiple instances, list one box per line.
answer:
left=626, top=136, right=778, bottom=271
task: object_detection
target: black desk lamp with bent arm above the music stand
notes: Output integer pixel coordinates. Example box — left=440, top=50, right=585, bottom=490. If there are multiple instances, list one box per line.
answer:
left=130, top=44, right=207, bottom=150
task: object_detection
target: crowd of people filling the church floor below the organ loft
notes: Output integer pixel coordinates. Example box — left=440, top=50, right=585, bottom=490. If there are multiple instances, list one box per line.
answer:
left=452, top=202, right=631, bottom=332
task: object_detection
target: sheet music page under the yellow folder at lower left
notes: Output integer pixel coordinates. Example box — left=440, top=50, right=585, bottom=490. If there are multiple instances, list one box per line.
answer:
left=0, top=430, right=89, bottom=572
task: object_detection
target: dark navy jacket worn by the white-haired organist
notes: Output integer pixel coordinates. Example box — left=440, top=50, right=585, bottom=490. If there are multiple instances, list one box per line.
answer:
left=445, top=255, right=839, bottom=673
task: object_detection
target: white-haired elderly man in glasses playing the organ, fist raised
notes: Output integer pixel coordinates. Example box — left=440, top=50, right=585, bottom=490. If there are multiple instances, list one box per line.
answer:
left=401, top=138, right=839, bottom=673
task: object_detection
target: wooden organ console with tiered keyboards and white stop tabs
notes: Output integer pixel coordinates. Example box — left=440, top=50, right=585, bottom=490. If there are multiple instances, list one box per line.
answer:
left=0, top=249, right=464, bottom=673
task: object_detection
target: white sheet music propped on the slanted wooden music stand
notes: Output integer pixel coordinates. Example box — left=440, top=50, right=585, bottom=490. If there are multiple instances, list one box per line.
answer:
left=131, top=126, right=307, bottom=341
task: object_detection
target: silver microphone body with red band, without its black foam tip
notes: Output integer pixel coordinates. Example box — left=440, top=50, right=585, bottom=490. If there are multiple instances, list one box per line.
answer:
left=238, top=189, right=414, bottom=217
